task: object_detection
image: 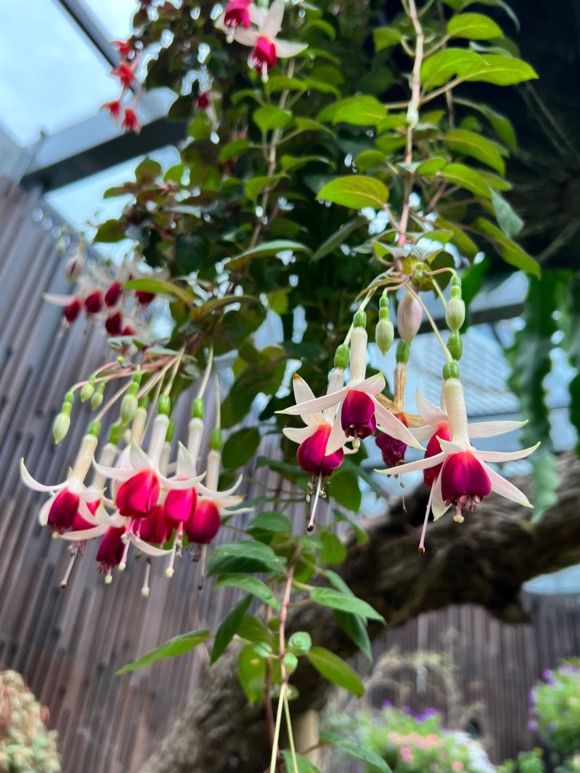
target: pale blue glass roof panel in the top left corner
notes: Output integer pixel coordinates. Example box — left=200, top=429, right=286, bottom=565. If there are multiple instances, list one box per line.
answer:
left=0, top=0, right=122, bottom=145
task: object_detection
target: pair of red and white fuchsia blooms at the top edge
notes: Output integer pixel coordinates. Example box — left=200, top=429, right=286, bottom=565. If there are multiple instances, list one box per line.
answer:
left=216, top=0, right=307, bottom=81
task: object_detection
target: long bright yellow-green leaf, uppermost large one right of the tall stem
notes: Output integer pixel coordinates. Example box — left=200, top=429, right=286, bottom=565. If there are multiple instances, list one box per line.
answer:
left=421, top=48, right=538, bottom=90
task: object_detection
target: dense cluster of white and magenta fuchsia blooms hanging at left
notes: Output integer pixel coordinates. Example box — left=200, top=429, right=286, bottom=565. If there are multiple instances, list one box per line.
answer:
left=21, top=378, right=242, bottom=596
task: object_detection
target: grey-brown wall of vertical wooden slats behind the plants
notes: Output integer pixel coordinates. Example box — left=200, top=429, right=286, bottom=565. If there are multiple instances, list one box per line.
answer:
left=0, top=180, right=580, bottom=773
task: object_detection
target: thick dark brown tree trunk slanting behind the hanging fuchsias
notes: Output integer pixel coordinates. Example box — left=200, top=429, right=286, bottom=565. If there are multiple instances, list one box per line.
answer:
left=143, top=456, right=580, bottom=773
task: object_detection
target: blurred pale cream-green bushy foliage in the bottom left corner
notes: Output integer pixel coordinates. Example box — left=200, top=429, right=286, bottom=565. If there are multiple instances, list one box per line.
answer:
left=0, top=671, right=61, bottom=773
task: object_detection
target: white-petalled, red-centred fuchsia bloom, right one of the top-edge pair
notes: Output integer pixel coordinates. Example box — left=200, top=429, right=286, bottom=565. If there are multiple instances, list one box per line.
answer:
left=225, top=0, right=307, bottom=80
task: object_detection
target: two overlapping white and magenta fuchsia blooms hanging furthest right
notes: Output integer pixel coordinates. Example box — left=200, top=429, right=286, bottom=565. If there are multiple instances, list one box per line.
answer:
left=377, top=378, right=540, bottom=552
